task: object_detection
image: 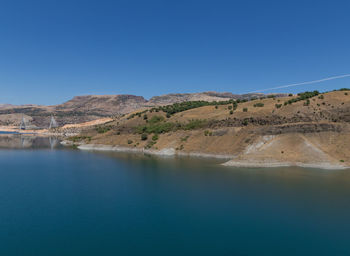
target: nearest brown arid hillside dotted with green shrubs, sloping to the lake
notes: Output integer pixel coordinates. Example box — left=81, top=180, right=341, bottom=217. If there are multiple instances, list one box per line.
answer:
left=71, top=90, right=350, bottom=168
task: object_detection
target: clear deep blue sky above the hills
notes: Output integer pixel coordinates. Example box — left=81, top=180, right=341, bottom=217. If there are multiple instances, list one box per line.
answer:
left=0, top=0, right=350, bottom=104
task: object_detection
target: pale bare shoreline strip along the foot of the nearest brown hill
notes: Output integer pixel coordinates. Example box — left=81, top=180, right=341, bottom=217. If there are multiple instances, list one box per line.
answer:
left=72, top=141, right=350, bottom=170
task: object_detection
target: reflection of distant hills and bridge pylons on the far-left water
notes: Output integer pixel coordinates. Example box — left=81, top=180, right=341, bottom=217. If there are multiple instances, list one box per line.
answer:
left=0, top=134, right=61, bottom=149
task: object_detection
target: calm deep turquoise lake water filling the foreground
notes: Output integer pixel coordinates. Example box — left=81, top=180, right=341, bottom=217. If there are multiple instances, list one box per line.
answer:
left=0, top=135, right=350, bottom=256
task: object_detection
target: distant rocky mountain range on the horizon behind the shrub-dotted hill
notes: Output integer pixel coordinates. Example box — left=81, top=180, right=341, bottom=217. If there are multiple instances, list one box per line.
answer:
left=0, top=92, right=286, bottom=128
